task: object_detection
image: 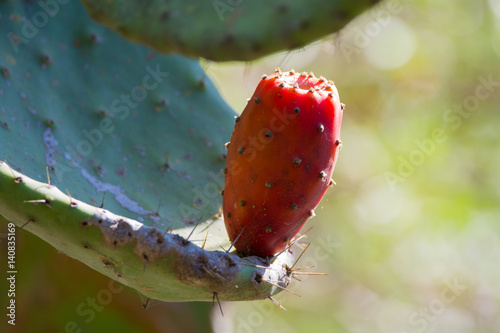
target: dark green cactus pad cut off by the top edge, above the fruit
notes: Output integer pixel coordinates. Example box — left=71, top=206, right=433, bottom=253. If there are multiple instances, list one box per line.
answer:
left=82, top=0, right=379, bottom=61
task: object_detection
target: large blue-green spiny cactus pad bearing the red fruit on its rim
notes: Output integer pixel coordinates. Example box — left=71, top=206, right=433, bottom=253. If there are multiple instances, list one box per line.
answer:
left=0, top=1, right=291, bottom=301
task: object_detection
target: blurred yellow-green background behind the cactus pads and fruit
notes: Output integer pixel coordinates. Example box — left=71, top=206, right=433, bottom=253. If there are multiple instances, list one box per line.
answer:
left=0, top=0, right=500, bottom=333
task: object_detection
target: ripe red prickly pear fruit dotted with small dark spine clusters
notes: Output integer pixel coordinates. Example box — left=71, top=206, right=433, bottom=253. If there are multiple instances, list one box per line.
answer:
left=223, top=69, right=343, bottom=256
